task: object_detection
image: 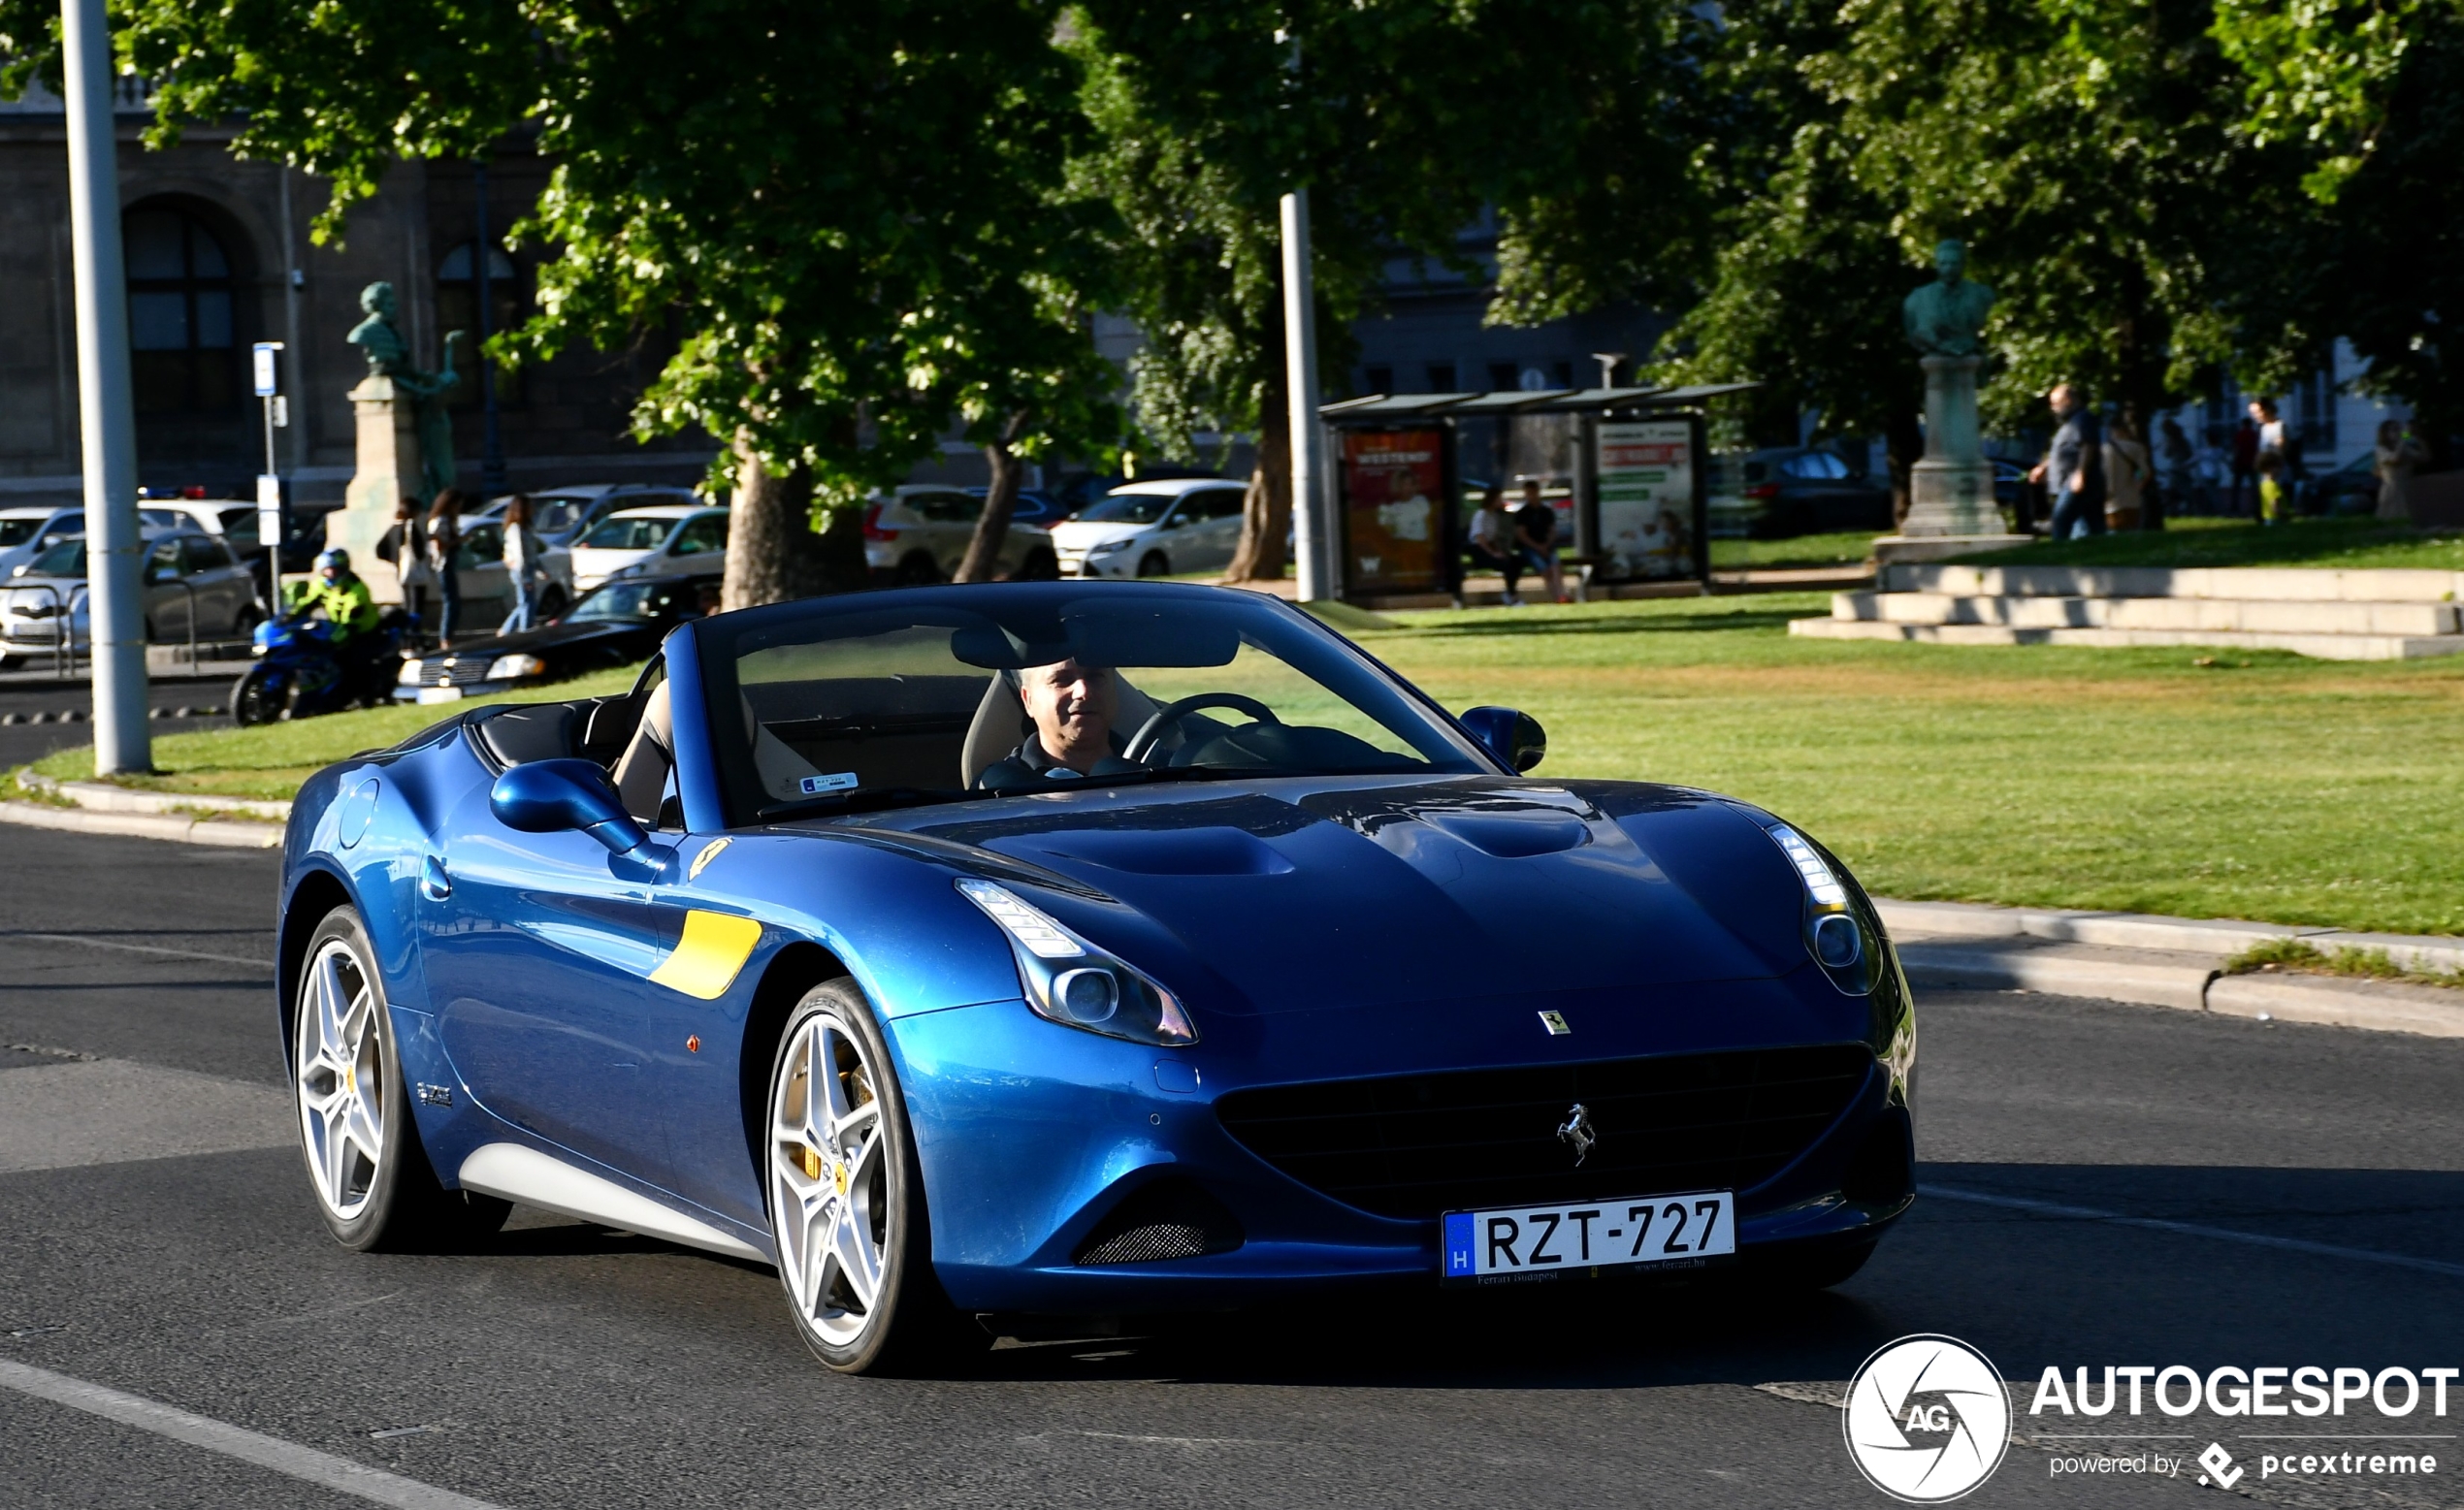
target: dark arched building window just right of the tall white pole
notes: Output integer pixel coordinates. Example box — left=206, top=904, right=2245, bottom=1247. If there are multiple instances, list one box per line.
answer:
left=120, top=205, right=239, bottom=414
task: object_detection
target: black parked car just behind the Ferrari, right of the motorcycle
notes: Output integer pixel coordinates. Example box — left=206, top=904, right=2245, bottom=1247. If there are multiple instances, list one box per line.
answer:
left=394, top=574, right=720, bottom=702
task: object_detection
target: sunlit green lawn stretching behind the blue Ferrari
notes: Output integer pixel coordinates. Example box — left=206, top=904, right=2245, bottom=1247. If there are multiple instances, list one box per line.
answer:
left=42, top=594, right=2464, bottom=934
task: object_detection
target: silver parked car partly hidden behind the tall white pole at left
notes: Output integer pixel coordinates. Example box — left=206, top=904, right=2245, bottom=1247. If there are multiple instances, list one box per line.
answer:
left=0, top=530, right=264, bottom=662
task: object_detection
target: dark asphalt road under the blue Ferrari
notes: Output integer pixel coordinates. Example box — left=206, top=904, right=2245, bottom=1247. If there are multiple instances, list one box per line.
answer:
left=0, top=830, right=2464, bottom=1510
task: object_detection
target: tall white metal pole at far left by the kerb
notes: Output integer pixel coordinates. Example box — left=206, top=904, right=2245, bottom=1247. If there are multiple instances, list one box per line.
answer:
left=59, top=0, right=152, bottom=776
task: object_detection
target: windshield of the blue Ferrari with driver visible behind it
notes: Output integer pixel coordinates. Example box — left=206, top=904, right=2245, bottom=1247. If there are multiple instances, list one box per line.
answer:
left=699, top=584, right=1491, bottom=822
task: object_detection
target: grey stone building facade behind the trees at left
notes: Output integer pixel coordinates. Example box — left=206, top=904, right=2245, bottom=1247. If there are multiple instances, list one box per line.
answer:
left=0, top=94, right=712, bottom=505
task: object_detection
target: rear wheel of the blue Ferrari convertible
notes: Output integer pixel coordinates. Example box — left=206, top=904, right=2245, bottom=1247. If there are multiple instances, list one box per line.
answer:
left=291, top=907, right=512, bottom=1254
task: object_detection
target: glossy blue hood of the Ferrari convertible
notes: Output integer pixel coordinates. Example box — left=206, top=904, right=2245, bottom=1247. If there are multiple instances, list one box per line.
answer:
left=830, top=779, right=1806, bottom=1012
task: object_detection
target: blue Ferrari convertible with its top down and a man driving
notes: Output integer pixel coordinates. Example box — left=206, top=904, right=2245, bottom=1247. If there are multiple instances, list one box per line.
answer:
left=278, top=581, right=1917, bottom=1372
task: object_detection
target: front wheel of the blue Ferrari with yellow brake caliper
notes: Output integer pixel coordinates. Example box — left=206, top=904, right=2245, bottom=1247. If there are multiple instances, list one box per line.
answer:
left=763, top=978, right=990, bottom=1374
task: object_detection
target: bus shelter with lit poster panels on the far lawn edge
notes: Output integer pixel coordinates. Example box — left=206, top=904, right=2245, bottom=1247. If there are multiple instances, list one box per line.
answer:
left=1318, top=382, right=1754, bottom=601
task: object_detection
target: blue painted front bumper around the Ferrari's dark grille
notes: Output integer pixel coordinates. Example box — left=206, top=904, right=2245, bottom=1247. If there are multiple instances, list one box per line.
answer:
left=890, top=968, right=1910, bottom=1315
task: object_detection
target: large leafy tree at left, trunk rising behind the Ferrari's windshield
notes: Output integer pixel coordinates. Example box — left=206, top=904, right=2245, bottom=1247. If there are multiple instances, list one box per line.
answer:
left=0, top=0, right=1119, bottom=606
